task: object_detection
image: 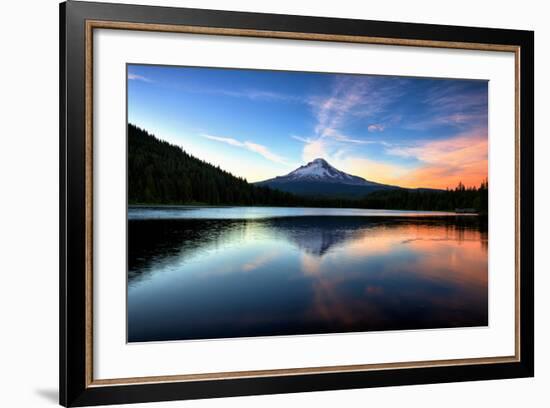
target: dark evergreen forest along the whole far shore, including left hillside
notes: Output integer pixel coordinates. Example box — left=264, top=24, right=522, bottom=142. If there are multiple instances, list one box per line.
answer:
left=128, top=124, right=488, bottom=214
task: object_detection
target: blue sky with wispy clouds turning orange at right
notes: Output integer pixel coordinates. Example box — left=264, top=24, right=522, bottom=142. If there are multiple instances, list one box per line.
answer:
left=127, top=64, right=488, bottom=189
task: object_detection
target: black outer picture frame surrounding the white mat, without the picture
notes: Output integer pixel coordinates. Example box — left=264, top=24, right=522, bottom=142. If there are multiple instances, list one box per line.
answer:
left=59, top=1, right=534, bottom=406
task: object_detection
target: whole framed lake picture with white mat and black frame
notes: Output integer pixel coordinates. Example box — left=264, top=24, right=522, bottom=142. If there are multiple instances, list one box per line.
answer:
left=60, top=1, right=534, bottom=406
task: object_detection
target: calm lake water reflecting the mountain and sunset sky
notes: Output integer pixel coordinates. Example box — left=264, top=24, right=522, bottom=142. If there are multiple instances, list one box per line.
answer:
left=128, top=207, right=488, bottom=342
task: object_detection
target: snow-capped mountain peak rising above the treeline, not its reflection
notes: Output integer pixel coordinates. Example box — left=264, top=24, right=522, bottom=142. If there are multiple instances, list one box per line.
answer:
left=256, top=159, right=401, bottom=199
